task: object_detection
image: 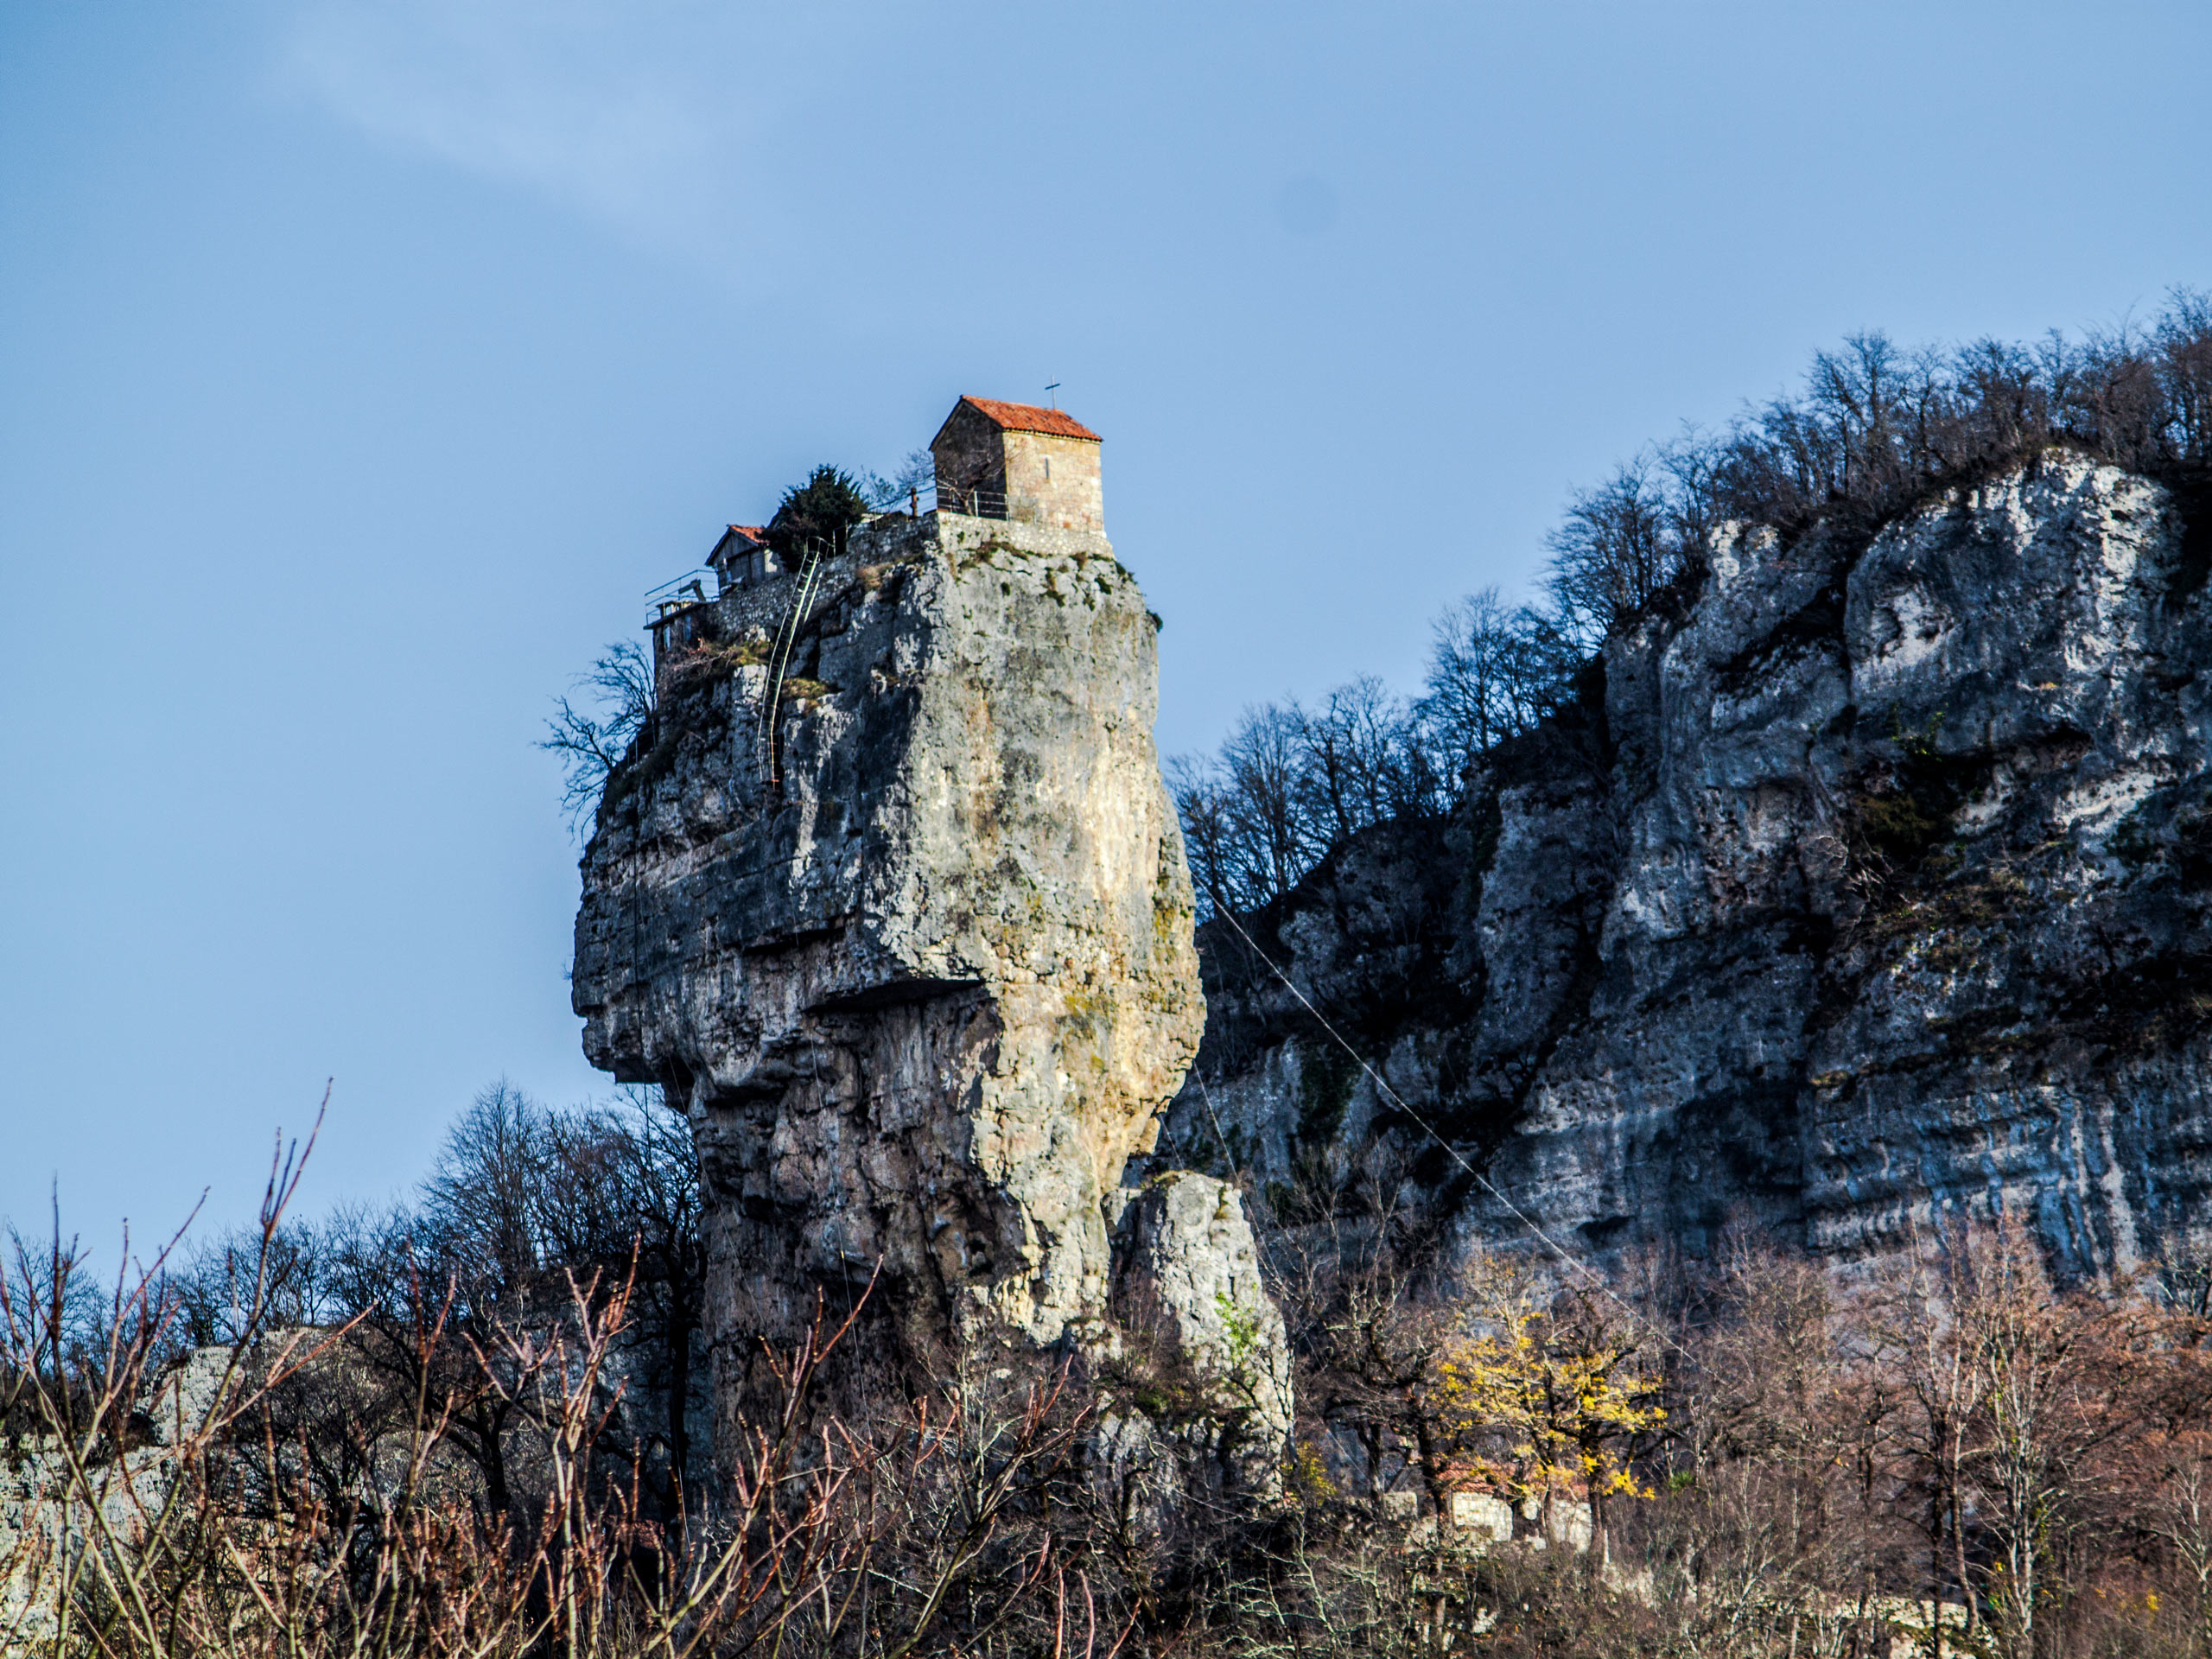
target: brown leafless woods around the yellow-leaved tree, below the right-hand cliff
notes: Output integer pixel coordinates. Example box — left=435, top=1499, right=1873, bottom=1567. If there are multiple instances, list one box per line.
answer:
left=1224, top=1219, right=2212, bottom=1659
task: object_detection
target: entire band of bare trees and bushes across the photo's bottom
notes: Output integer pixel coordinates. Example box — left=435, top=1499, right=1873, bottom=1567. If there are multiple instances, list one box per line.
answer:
left=13, top=1090, right=2212, bottom=1659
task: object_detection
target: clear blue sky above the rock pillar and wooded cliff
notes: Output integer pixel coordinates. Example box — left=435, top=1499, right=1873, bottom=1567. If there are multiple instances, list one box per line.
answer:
left=0, top=0, right=2212, bottom=1239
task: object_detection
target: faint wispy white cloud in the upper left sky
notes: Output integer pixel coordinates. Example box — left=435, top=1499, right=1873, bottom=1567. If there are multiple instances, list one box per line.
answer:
left=283, top=0, right=766, bottom=254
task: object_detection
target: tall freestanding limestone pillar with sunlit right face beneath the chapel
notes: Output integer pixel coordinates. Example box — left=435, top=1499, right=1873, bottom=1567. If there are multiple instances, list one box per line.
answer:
left=562, top=513, right=1204, bottom=1380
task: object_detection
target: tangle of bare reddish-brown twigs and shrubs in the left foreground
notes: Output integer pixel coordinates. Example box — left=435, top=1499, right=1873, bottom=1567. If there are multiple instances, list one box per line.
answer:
left=0, top=1119, right=1130, bottom=1659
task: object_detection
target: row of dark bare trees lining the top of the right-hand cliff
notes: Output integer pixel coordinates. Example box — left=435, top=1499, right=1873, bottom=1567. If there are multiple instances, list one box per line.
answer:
left=1170, top=292, right=2212, bottom=912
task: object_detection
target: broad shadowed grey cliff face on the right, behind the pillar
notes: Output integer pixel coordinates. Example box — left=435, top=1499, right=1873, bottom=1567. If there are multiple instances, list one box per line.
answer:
left=1168, top=454, right=2212, bottom=1269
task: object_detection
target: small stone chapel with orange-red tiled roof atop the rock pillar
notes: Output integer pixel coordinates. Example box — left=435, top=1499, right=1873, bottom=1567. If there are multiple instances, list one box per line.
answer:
left=929, top=398, right=1106, bottom=531
